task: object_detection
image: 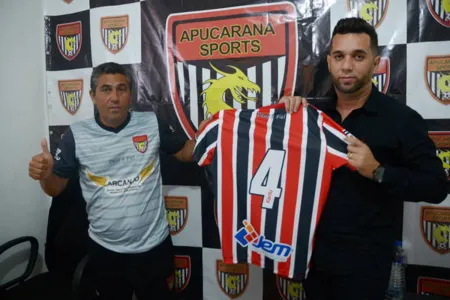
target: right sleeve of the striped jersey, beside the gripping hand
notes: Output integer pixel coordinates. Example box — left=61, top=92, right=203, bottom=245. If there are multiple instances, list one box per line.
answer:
left=321, top=112, right=354, bottom=169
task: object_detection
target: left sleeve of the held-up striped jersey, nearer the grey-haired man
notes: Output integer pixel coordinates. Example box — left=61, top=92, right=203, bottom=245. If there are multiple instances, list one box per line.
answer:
left=193, top=114, right=219, bottom=167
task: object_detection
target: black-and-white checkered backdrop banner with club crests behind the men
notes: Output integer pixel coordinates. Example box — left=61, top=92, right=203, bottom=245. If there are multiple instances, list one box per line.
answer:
left=45, top=0, right=450, bottom=300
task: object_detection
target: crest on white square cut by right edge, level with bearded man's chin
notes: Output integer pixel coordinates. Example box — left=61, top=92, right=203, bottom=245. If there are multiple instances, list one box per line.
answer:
left=425, top=55, right=450, bottom=104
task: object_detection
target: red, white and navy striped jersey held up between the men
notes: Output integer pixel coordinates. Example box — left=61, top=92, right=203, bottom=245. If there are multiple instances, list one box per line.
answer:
left=194, top=104, right=356, bottom=278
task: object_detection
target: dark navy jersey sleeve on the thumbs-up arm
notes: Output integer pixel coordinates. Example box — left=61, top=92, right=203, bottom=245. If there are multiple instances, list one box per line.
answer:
left=53, top=127, right=78, bottom=178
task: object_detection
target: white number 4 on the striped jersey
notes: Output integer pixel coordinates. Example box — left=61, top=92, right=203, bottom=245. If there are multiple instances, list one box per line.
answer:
left=250, top=149, right=286, bottom=209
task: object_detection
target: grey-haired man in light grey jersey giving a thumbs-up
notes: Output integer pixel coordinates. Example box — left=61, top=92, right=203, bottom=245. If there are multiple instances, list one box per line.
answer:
left=29, top=63, right=202, bottom=300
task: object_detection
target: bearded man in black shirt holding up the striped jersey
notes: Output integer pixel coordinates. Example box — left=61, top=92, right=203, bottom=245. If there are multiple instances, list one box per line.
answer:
left=280, top=18, right=447, bottom=300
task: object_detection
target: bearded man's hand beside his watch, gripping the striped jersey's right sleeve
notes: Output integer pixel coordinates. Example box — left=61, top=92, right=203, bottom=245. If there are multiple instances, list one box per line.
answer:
left=345, top=136, right=380, bottom=179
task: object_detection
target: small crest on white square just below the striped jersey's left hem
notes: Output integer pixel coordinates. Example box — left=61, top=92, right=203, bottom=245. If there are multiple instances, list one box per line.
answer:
left=216, top=260, right=250, bottom=299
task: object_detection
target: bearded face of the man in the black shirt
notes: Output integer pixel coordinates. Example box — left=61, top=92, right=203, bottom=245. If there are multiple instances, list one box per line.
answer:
left=327, top=33, right=380, bottom=94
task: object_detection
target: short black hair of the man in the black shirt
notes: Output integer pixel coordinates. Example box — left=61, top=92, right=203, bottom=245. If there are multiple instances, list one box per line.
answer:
left=330, top=17, right=378, bottom=55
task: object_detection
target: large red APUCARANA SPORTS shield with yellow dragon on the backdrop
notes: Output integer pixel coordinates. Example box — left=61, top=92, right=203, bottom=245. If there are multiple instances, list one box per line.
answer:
left=166, top=2, right=298, bottom=138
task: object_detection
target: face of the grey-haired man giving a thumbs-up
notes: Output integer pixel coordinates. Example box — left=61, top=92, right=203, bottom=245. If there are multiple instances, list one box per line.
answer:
left=90, top=74, right=131, bottom=127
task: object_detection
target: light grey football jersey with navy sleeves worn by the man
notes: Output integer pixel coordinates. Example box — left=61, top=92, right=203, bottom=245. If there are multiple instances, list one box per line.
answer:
left=54, top=112, right=185, bottom=253
